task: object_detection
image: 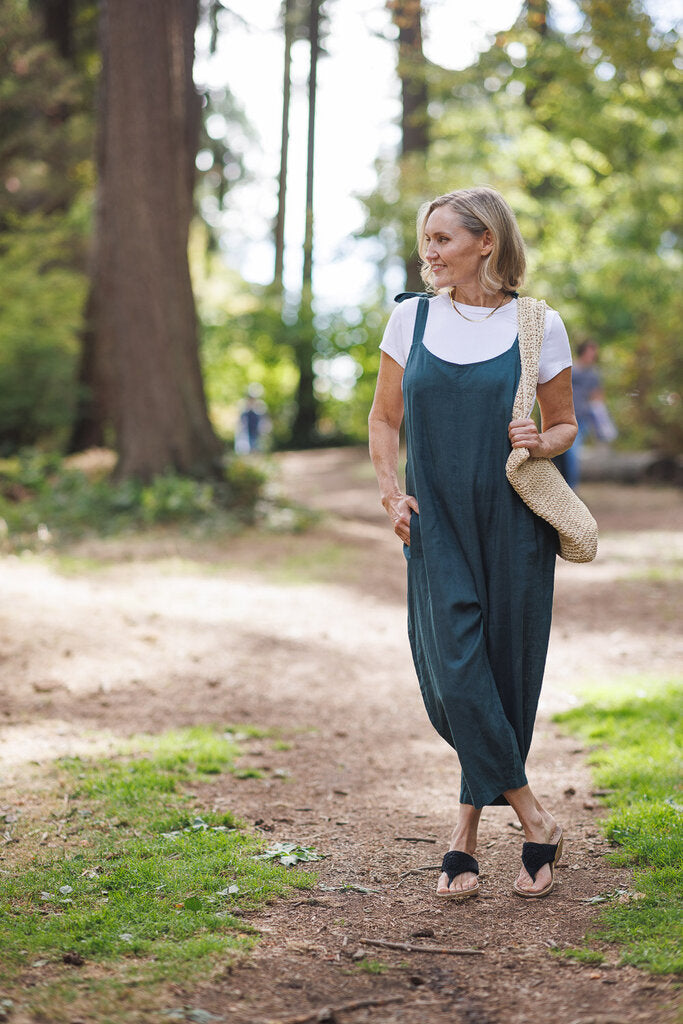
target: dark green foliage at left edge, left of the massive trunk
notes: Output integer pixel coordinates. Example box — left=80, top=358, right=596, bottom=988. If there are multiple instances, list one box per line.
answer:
left=0, top=0, right=96, bottom=454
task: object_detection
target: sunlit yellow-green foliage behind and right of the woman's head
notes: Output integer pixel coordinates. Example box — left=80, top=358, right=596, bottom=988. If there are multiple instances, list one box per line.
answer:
left=364, top=0, right=683, bottom=454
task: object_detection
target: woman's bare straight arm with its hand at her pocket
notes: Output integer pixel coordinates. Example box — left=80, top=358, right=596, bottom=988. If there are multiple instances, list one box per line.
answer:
left=368, top=352, right=419, bottom=544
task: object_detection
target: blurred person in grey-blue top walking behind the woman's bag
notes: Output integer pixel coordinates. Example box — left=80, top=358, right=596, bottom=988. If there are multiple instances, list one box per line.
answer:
left=555, top=338, right=617, bottom=490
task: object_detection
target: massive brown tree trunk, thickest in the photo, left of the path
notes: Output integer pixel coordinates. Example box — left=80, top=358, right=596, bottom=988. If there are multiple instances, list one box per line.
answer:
left=93, top=0, right=221, bottom=479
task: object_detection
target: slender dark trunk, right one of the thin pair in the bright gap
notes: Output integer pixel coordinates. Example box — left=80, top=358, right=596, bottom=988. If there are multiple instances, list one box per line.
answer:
left=292, top=0, right=321, bottom=447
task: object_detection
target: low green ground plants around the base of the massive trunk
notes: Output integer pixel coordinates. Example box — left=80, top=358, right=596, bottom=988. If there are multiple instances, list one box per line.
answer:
left=0, top=450, right=269, bottom=549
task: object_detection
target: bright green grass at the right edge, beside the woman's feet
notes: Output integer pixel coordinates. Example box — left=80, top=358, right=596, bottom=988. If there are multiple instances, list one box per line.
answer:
left=556, top=679, right=683, bottom=973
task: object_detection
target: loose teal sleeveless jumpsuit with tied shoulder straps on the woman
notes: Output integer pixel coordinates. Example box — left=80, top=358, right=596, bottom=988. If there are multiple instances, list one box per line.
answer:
left=398, top=293, right=558, bottom=807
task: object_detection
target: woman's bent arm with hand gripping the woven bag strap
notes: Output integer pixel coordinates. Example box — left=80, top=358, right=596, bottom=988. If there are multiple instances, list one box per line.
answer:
left=508, top=367, right=578, bottom=459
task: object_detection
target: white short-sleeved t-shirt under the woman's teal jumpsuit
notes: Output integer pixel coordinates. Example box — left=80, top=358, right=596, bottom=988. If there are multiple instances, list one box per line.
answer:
left=380, top=292, right=571, bottom=384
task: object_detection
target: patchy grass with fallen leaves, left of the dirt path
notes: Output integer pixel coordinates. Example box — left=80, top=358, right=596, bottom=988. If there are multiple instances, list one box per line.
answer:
left=0, top=728, right=314, bottom=1021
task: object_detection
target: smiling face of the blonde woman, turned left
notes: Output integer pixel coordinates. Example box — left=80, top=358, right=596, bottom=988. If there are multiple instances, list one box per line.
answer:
left=424, top=206, right=494, bottom=289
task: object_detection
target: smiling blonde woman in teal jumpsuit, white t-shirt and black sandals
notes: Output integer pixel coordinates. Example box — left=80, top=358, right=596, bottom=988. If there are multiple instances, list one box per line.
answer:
left=370, top=187, right=577, bottom=898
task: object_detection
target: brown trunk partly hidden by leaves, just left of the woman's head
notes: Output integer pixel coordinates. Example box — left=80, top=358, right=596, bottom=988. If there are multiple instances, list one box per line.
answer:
left=387, top=0, right=429, bottom=292
